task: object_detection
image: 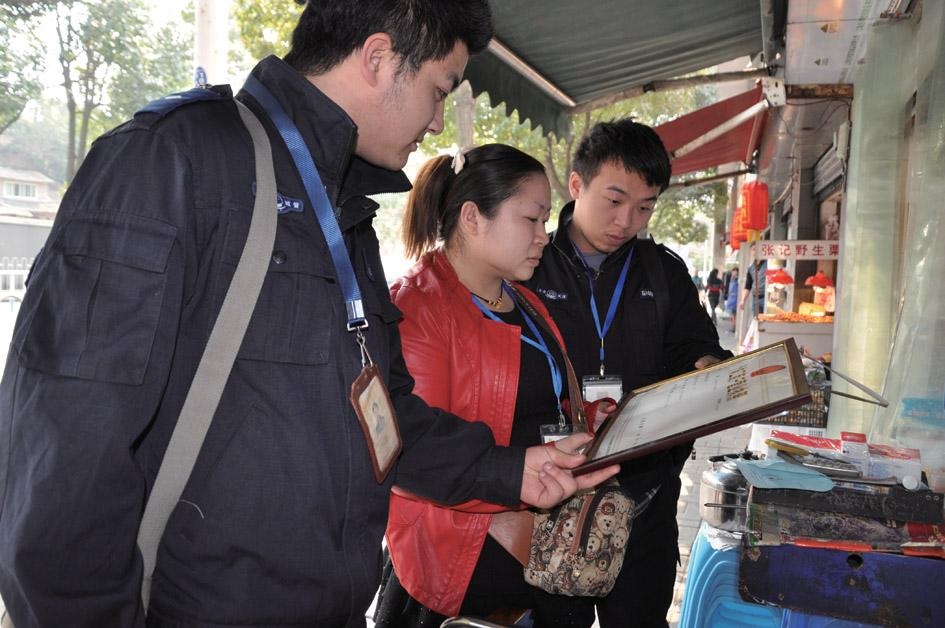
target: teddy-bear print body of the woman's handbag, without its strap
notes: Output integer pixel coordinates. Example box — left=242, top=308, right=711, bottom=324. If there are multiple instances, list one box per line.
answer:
left=525, top=482, right=633, bottom=597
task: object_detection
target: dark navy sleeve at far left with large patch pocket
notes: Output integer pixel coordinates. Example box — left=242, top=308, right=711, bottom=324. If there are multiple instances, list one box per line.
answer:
left=0, top=127, right=193, bottom=628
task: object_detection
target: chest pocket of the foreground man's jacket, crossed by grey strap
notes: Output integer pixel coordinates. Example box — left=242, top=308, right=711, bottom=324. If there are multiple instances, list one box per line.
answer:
left=222, top=211, right=343, bottom=365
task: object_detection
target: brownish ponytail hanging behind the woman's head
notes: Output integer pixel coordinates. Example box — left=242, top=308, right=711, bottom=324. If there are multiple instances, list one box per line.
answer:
left=403, top=155, right=456, bottom=258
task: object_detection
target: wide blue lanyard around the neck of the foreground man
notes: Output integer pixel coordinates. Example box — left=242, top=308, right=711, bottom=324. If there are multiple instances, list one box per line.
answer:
left=243, top=76, right=368, bottom=331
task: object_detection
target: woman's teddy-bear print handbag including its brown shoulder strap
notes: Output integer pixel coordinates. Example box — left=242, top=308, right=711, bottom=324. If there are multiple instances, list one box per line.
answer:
left=489, top=286, right=635, bottom=597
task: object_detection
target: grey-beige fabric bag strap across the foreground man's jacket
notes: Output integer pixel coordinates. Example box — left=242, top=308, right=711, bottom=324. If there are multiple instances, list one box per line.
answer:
left=138, top=100, right=277, bottom=612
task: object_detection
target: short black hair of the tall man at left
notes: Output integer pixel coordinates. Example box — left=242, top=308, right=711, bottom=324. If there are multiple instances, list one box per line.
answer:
left=285, top=0, right=493, bottom=75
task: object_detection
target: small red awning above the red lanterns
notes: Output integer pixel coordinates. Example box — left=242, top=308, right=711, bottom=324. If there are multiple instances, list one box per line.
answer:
left=654, top=85, right=768, bottom=176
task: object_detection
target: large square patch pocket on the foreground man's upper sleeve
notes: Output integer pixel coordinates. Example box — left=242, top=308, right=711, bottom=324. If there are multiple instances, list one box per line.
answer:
left=14, top=215, right=177, bottom=384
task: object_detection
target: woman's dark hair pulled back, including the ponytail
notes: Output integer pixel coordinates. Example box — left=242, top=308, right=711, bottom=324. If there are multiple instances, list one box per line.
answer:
left=403, top=144, right=545, bottom=257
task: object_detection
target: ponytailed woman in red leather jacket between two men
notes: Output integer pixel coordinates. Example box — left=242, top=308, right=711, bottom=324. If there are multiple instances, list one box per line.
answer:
left=375, top=144, right=604, bottom=627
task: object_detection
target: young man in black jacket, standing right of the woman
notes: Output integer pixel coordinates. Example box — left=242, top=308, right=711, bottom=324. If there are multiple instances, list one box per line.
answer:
left=528, top=120, right=730, bottom=628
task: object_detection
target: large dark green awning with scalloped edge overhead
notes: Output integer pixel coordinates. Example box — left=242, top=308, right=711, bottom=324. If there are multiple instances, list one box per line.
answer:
left=466, top=0, right=762, bottom=134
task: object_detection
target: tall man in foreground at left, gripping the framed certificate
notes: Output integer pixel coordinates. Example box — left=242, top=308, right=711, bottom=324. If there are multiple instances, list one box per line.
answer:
left=0, top=0, right=601, bottom=628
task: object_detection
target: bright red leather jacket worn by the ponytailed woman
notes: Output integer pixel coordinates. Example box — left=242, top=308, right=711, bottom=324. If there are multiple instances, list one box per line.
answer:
left=387, top=251, right=563, bottom=615
